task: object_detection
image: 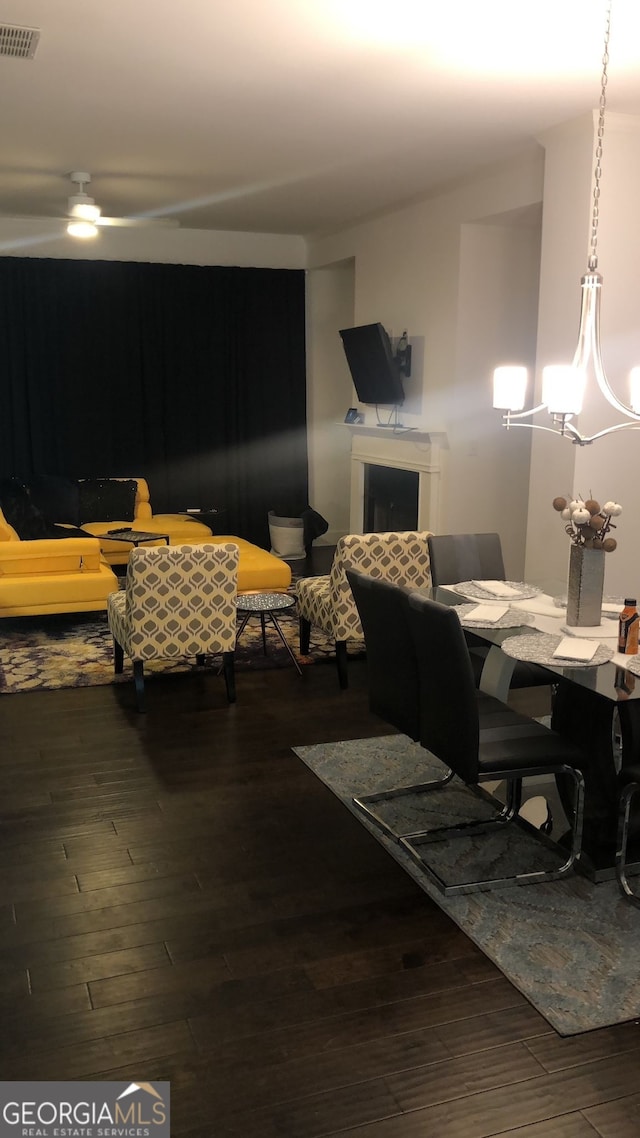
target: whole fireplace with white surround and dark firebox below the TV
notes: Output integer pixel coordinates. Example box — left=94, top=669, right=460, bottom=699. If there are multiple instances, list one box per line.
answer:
left=348, top=424, right=444, bottom=534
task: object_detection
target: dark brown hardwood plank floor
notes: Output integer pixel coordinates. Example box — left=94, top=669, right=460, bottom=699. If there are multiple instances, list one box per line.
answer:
left=0, top=546, right=640, bottom=1138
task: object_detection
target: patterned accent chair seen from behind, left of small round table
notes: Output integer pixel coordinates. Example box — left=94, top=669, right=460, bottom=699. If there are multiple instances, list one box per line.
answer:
left=107, top=543, right=239, bottom=711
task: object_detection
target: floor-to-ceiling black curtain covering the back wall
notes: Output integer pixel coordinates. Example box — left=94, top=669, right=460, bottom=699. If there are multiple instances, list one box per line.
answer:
left=0, top=257, right=309, bottom=545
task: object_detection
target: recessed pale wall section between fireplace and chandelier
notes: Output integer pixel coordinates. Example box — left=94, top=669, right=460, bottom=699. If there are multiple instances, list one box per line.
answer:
left=448, top=207, right=540, bottom=580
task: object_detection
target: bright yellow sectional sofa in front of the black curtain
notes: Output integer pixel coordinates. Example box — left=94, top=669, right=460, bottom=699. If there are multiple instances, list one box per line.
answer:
left=0, top=478, right=292, bottom=617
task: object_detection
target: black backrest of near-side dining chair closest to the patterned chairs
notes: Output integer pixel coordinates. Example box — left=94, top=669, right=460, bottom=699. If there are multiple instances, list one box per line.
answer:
left=346, top=569, right=420, bottom=741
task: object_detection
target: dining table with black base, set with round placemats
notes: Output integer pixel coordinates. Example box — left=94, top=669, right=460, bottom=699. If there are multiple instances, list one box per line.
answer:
left=429, top=585, right=640, bottom=882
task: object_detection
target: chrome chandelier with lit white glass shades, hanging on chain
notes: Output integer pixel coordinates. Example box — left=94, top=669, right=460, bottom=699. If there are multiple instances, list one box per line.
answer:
left=493, top=0, right=640, bottom=446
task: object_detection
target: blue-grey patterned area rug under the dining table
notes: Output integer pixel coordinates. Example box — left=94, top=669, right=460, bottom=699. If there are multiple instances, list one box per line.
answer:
left=294, top=735, right=640, bottom=1036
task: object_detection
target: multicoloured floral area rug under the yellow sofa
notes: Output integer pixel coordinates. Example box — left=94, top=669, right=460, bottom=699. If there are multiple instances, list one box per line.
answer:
left=0, top=609, right=363, bottom=694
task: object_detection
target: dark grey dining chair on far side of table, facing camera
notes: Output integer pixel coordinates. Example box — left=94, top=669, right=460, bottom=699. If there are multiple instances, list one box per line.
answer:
left=427, top=534, right=552, bottom=688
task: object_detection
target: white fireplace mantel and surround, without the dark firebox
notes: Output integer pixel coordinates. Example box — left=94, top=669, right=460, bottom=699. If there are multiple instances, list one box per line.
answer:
left=345, top=423, right=445, bottom=534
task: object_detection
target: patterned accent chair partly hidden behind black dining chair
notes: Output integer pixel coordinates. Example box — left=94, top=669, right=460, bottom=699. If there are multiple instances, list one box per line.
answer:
left=296, top=529, right=432, bottom=687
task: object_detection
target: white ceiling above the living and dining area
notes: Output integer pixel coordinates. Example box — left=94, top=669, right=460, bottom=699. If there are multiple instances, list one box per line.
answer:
left=0, top=0, right=640, bottom=234
